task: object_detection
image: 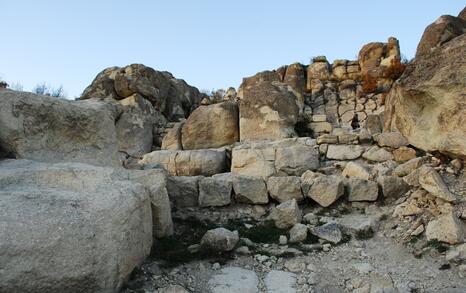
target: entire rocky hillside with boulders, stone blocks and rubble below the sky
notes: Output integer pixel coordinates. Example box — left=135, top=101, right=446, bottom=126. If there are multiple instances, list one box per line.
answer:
left=0, top=6, right=466, bottom=293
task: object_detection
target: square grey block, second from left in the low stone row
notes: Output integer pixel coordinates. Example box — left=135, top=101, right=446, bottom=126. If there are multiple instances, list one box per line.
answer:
left=199, top=177, right=233, bottom=207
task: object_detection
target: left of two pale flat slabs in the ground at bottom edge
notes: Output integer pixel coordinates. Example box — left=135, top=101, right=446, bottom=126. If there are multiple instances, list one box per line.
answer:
left=209, top=267, right=260, bottom=293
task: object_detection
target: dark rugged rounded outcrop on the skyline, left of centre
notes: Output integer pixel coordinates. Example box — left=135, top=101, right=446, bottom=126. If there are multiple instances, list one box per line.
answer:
left=80, top=64, right=203, bottom=121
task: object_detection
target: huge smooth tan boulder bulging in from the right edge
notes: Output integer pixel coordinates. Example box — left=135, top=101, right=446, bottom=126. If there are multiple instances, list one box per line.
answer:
left=385, top=34, right=466, bottom=157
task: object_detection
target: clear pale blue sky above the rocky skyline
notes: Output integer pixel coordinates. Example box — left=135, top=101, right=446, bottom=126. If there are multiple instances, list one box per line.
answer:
left=0, top=0, right=465, bottom=97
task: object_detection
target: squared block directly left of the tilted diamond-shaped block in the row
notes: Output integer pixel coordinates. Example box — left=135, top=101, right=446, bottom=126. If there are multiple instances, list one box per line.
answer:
left=267, top=176, right=303, bottom=203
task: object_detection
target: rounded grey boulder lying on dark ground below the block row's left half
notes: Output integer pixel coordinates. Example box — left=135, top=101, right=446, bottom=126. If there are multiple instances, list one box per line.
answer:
left=201, top=228, right=239, bottom=251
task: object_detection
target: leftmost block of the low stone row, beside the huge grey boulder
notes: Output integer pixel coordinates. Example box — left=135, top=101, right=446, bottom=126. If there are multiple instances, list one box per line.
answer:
left=167, top=176, right=202, bottom=208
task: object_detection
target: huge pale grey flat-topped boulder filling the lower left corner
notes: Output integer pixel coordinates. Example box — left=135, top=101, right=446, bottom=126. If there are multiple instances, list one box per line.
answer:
left=0, top=160, right=159, bottom=293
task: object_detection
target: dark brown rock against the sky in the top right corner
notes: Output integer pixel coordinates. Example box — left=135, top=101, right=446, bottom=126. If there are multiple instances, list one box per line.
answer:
left=416, top=15, right=466, bottom=58
